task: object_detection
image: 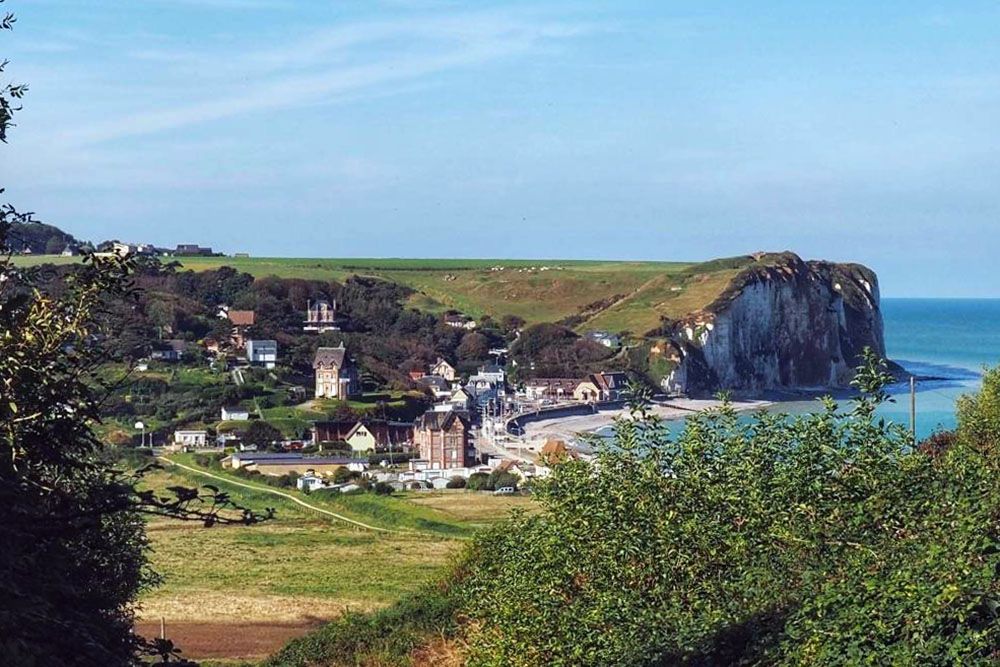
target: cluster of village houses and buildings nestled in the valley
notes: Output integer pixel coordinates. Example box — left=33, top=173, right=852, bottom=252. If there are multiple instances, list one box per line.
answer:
left=160, top=298, right=628, bottom=494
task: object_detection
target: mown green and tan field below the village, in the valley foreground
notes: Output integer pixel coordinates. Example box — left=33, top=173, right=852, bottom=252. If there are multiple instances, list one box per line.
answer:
left=139, top=455, right=531, bottom=664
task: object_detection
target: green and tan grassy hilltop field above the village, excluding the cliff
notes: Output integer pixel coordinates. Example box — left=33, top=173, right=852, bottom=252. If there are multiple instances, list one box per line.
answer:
left=16, top=256, right=753, bottom=335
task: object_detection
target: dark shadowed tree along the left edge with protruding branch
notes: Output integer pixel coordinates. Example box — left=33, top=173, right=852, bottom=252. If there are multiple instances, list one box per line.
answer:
left=0, top=7, right=266, bottom=666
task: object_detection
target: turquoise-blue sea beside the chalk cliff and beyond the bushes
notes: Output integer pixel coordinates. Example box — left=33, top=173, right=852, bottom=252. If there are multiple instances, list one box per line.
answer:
left=599, top=298, right=1000, bottom=439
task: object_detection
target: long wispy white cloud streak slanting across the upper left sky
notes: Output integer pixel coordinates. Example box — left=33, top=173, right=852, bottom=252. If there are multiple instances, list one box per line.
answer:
left=56, top=10, right=595, bottom=146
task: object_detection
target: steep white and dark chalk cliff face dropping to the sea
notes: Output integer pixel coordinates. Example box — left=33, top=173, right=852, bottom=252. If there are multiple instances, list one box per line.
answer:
left=663, top=253, right=885, bottom=394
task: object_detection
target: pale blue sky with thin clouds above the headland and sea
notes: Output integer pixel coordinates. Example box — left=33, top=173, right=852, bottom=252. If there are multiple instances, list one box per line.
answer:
left=0, top=0, right=1000, bottom=297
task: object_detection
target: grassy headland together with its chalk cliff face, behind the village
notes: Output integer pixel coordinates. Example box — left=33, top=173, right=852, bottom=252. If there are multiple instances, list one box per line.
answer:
left=17, top=252, right=885, bottom=393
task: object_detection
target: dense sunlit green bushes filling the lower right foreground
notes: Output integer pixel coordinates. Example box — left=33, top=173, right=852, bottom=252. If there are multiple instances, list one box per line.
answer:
left=461, top=358, right=1000, bottom=665
